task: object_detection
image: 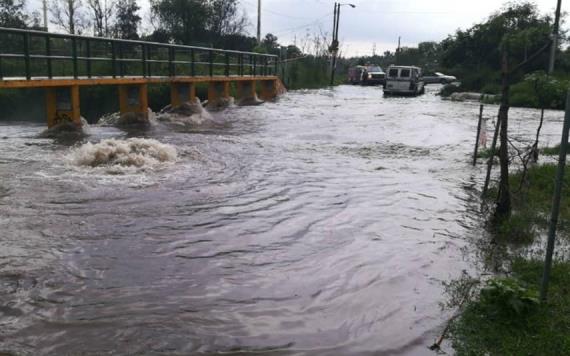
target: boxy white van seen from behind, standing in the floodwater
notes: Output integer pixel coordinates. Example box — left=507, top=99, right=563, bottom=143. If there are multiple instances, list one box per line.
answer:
left=384, top=66, right=425, bottom=95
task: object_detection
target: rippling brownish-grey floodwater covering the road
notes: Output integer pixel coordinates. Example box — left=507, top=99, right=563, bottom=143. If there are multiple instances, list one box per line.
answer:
left=0, top=86, right=562, bottom=355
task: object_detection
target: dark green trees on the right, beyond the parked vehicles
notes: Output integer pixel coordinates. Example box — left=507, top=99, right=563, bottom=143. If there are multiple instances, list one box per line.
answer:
left=348, top=1, right=570, bottom=101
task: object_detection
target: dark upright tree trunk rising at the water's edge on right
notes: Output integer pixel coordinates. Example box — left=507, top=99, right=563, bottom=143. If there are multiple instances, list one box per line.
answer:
left=495, top=52, right=511, bottom=217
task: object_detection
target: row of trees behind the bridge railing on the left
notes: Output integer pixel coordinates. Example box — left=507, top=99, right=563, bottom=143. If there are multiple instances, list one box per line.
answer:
left=0, top=0, right=306, bottom=55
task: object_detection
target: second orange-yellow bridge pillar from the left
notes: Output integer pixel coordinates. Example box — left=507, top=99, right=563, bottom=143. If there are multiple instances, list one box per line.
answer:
left=119, top=84, right=149, bottom=125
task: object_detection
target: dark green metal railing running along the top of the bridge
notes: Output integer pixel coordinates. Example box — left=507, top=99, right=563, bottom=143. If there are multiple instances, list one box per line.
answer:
left=0, top=27, right=278, bottom=80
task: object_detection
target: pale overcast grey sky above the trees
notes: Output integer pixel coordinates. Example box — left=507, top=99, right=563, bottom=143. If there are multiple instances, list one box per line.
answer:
left=28, top=0, right=560, bottom=56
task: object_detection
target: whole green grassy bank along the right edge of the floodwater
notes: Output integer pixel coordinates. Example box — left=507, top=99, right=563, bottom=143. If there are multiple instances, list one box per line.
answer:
left=450, top=164, right=570, bottom=355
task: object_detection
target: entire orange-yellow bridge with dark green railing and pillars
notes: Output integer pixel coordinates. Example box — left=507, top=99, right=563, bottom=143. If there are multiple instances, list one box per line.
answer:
left=0, top=27, right=282, bottom=127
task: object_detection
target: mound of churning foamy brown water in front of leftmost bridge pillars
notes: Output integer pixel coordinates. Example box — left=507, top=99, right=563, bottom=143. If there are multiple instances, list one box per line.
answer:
left=68, top=138, right=177, bottom=174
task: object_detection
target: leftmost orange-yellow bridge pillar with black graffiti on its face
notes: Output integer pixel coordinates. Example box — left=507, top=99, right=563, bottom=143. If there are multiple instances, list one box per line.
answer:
left=46, top=85, right=81, bottom=128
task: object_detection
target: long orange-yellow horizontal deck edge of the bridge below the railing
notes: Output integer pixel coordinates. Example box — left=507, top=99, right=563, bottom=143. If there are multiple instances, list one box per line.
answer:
left=0, top=75, right=277, bottom=89
